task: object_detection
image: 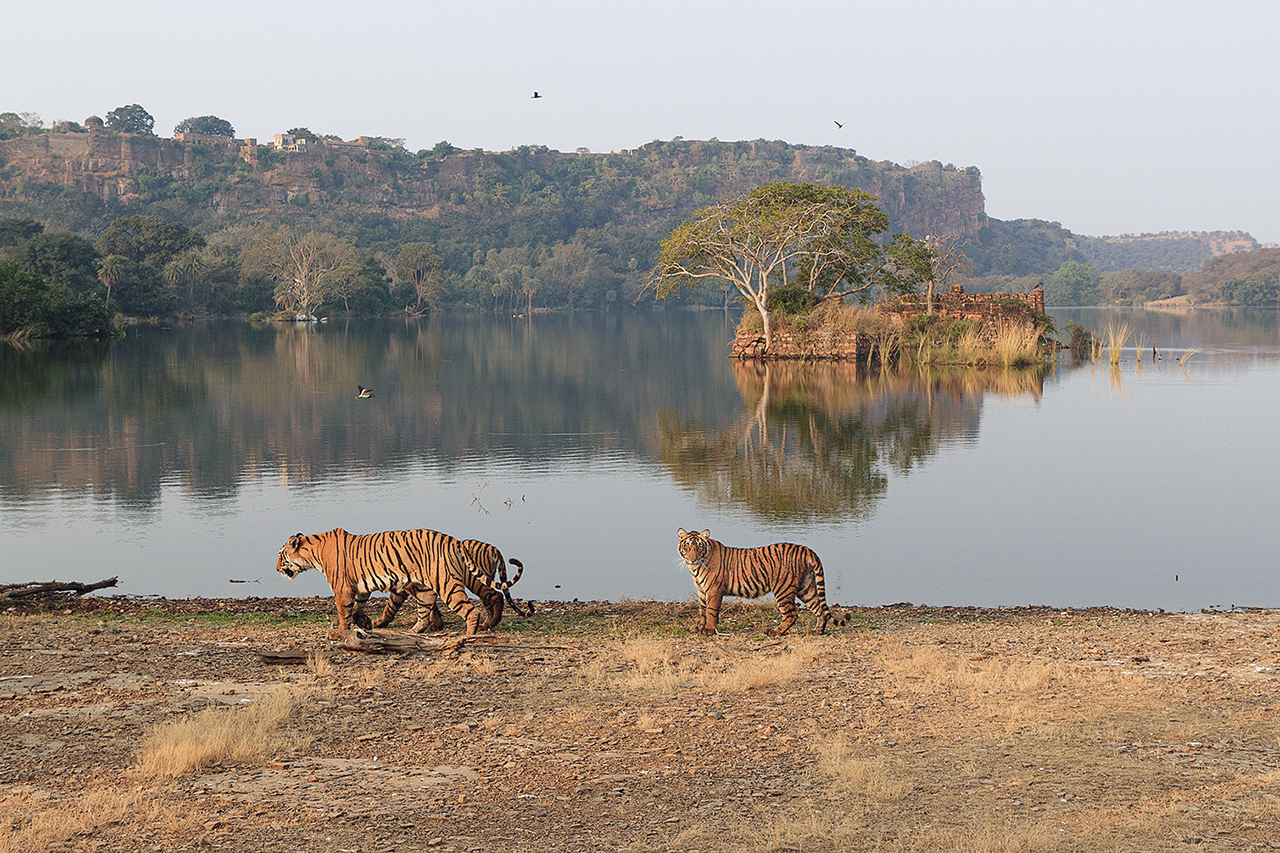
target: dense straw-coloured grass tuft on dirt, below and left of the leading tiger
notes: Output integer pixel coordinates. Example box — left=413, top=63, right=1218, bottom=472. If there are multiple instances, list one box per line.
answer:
left=137, top=688, right=311, bottom=776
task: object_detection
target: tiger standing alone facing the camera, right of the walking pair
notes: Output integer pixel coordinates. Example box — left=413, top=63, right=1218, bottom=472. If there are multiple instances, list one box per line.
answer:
left=677, top=528, right=831, bottom=637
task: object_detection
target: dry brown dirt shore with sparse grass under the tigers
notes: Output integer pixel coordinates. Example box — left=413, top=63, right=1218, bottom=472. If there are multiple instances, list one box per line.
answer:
left=0, top=597, right=1280, bottom=853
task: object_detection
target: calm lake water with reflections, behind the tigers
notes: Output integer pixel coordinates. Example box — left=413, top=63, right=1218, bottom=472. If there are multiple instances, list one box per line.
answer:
left=0, top=309, right=1280, bottom=610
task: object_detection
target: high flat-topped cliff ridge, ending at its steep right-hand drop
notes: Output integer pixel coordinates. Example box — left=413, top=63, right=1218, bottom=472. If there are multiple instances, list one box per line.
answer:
left=0, top=129, right=987, bottom=237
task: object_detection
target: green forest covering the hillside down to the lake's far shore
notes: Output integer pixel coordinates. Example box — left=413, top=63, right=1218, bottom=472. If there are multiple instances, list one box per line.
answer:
left=0, top=104, right=1276, bottom=335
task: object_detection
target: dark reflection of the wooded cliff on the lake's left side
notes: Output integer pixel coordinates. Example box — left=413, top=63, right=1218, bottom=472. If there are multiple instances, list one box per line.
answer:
left=0, top=314, right=739, bottom=510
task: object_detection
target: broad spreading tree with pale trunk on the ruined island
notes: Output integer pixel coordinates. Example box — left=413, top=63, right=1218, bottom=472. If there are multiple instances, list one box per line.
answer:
left=655, top=182, right=933, bottom=352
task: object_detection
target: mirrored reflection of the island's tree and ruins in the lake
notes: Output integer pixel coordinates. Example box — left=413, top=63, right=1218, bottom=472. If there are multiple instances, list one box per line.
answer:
left=662, top=362, right=1044, bottom=521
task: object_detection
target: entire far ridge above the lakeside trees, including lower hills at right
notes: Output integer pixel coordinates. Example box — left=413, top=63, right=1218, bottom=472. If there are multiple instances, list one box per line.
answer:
left=0, top=126, right=1258, bottom=278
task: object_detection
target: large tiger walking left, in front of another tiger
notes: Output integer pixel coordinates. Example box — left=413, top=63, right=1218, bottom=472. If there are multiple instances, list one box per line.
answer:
left=275, top=528, right=502, bottom=639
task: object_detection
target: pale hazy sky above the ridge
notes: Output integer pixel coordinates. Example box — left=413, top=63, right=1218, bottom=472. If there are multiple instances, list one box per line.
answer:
left=10, top=0, right=1280, bottom=242
